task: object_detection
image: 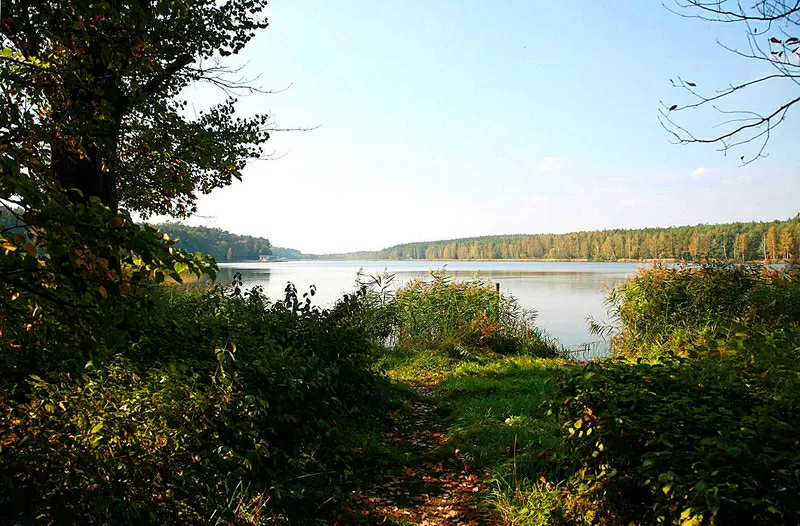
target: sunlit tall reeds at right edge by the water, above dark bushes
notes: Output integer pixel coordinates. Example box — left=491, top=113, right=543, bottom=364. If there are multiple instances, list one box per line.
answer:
left=607, top=264, right=800, bottom=357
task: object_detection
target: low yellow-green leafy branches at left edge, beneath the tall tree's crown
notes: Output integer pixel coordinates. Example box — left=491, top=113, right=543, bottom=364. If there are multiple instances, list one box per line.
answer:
left=0, top=179, right=215, bottom=374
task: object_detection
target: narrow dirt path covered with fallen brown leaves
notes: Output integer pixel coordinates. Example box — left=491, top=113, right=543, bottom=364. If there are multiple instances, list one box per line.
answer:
left=342, top=386, right=491, bottom=526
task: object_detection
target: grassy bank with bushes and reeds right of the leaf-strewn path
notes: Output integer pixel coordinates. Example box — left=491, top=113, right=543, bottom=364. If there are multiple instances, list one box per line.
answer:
left=344, top=267, right=800, bottom=526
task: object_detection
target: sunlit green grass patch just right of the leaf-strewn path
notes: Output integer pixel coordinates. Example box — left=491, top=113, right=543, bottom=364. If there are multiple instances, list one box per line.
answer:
left=384, top=350, right=564, bottom=524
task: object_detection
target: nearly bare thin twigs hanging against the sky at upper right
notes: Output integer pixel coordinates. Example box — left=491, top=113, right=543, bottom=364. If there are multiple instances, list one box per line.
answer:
left=659, top=0, right=800, bottom=164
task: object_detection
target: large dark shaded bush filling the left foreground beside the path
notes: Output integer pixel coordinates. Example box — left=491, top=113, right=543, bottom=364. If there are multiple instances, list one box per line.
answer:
left=0, top=280, right=388, bottom=524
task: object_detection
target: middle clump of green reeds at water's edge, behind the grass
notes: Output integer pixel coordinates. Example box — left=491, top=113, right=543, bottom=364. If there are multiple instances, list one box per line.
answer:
left=394, top=272, right=559, bottom=357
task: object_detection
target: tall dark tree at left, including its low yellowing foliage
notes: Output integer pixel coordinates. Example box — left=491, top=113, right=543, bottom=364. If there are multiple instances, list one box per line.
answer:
left=0, top=0, right=271, bottom=338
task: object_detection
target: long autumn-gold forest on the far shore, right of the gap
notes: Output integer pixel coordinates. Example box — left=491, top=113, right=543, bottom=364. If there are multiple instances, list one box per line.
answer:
left=344, top=214, right=800, bottom=261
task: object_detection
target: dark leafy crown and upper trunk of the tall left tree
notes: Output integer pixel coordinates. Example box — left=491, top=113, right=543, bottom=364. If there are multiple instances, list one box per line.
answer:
left=0, top=0, right=270, bottom=216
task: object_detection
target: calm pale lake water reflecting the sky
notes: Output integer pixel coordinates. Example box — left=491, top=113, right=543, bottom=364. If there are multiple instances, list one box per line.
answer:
left=217, top=261, right=643, bottom=346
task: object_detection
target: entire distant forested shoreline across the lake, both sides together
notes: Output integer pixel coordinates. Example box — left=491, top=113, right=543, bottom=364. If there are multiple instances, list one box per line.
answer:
left=147, top=214, right=800, bottom=263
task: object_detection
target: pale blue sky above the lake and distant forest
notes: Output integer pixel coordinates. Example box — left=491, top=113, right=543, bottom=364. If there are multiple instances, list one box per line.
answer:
left=178, top=0, right=800, bottom=254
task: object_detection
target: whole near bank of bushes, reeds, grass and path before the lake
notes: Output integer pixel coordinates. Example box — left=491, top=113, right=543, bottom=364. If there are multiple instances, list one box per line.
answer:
left=0, top=264, right=800, bottom=526
